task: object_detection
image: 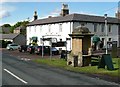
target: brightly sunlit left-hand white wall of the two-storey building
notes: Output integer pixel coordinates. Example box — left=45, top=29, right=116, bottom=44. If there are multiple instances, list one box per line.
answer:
left=27, top=22, right=72, bottom=51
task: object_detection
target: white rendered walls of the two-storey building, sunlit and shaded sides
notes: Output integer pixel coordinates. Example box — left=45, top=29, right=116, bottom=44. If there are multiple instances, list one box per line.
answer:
left=27, top=22, right=119, bottom=51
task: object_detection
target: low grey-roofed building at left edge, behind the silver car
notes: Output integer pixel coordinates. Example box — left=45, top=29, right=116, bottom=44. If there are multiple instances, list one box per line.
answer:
left=0, top=34, right=26, bottom=45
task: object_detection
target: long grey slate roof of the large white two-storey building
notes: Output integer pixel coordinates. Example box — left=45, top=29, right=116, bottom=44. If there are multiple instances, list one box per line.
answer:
left=28, top=14, right=120, bottom=26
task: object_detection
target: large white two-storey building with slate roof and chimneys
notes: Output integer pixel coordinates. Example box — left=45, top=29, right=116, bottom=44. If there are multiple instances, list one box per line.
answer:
left=27, top=4, right=120, bottom=51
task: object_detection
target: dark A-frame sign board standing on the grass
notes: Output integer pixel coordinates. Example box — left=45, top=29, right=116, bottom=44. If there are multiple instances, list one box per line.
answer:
left=98, top=54, right=114, bottom=70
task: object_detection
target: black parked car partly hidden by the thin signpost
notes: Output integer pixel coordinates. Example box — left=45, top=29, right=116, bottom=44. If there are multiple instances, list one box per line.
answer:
left=35, top=46, right=50, bottom=55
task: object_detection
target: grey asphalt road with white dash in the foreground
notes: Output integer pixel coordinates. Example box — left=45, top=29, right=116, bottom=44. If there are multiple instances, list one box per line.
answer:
left=0, top=53, right=119, bottom=87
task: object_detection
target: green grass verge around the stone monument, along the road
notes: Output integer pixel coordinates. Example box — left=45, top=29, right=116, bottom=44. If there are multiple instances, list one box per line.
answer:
left=33, top=58, right=120, bottom=77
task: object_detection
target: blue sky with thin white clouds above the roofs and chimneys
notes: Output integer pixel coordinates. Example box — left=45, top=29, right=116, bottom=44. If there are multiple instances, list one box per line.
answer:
left=0, top=1, right=118, bottom=25
